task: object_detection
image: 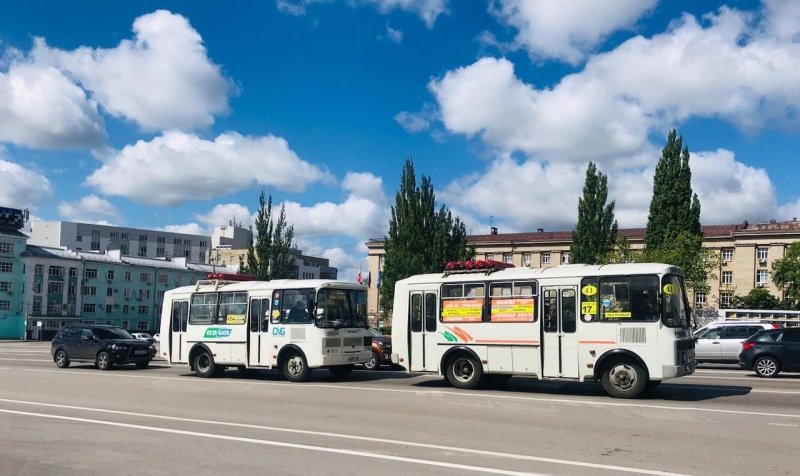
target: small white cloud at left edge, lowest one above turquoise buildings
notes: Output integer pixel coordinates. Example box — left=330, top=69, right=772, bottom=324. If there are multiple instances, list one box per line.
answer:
left=0, top=156, right=53, bottom=208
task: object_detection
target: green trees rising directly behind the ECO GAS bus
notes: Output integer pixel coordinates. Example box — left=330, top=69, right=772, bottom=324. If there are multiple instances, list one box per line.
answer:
left=239, top=190, right=297, bottom=281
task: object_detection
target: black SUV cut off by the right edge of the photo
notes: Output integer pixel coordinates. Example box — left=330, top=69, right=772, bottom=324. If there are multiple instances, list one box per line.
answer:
left=739, top=327, right=800, bottom=377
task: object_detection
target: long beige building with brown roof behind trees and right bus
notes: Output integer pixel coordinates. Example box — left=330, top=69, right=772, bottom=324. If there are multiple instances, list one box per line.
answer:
left=366, top=218, right=800, bottom=316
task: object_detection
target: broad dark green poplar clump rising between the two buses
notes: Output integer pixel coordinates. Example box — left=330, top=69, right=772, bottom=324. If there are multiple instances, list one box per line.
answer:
left=380, top=158, right=475, bottom=312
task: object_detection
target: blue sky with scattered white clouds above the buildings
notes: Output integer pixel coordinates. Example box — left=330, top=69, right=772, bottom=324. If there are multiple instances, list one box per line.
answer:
left=0, top=0, right=800, bottom=280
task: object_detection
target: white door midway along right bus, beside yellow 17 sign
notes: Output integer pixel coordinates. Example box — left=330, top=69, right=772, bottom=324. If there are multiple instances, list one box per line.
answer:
left=542, top=286, right=578, bottom=378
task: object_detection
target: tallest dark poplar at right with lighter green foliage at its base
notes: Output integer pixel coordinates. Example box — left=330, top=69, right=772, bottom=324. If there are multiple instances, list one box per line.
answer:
left=641, top=129, right=719, bottom=292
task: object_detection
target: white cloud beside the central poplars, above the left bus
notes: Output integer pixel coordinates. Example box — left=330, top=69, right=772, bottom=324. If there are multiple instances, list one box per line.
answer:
left=284, top=173, right=389, bottom=241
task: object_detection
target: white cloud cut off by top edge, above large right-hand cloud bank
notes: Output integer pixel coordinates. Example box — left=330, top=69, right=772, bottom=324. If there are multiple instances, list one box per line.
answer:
left=489, top=0, right=658, bottom=64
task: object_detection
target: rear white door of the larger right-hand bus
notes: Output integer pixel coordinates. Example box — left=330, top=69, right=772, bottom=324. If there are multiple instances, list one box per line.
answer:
left=408, top=291, right=439, bottom=371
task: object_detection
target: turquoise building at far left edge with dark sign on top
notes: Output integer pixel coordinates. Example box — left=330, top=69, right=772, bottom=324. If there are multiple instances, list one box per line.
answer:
left=0, top=207, right=28, bottom=339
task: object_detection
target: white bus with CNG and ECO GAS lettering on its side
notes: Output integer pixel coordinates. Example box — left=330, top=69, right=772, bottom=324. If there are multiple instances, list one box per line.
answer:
left=159, top=279, right=372, bottom=382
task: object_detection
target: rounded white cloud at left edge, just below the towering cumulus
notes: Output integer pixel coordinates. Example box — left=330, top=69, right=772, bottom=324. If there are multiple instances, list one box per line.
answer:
left=0, top=58, right=105, bottom=149
